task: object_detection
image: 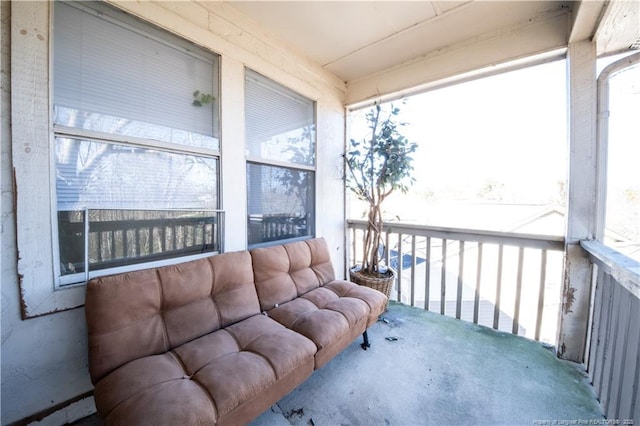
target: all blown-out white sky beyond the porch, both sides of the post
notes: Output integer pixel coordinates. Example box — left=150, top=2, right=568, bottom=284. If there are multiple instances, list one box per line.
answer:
left=350, top=57, right=640, bottom=250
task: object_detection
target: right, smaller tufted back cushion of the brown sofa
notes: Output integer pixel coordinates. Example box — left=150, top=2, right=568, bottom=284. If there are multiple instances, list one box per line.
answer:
left=251, top=238, right=335, bottom=311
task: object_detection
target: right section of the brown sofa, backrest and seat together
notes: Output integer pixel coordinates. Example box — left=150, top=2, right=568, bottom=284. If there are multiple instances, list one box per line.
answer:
left=251, top=238, right=386, bottom=369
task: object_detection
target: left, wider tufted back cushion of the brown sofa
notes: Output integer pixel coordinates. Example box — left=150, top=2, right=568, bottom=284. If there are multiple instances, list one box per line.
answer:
left=85, top=251, right=260, bottom=383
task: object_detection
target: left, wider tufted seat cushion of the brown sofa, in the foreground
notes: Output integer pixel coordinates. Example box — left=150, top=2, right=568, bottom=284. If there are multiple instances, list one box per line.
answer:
left=95, top=315, right=316, bottom=424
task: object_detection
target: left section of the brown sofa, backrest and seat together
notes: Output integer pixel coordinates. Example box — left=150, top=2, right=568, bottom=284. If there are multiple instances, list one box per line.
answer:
left=85, top=251, right=315, bottom=425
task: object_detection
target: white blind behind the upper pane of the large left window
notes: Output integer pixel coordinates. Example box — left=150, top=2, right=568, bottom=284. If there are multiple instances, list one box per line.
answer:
left=53, top=2, right=219, bottom=150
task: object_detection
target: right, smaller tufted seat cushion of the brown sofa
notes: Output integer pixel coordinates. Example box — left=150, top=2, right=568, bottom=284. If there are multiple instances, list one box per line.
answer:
left=268, top=287, right=369, bottom=369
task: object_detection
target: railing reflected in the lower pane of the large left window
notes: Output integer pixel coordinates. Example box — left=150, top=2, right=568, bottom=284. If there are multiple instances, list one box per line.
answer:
left=58, top=210, right=223, bottom=275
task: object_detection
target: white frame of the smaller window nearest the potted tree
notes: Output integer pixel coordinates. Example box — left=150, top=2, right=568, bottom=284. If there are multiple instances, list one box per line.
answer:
left=244, top=67, right=318, bottom=249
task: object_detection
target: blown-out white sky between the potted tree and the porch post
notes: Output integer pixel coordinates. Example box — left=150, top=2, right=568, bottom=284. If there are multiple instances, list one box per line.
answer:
left=352, top=61, right=567, bottom=210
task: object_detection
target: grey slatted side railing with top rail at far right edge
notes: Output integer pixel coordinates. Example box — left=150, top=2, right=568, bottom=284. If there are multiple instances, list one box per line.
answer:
left=581, top=241, right=640, bottom=424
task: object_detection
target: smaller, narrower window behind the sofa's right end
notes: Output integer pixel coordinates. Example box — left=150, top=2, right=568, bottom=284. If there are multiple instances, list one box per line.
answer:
left=245, top=70, right=316, bottom=247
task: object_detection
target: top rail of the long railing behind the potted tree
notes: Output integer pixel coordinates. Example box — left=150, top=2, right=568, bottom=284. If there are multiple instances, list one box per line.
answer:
left=347, top=220, right=565, bottom=251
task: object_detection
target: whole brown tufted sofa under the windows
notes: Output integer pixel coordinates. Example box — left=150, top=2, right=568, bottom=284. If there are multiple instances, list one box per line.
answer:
left=85, top=238, right=386, bottom=425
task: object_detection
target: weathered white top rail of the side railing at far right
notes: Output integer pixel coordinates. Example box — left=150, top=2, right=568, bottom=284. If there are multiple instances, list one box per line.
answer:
left=580, top=240, right=640, bottom=298
